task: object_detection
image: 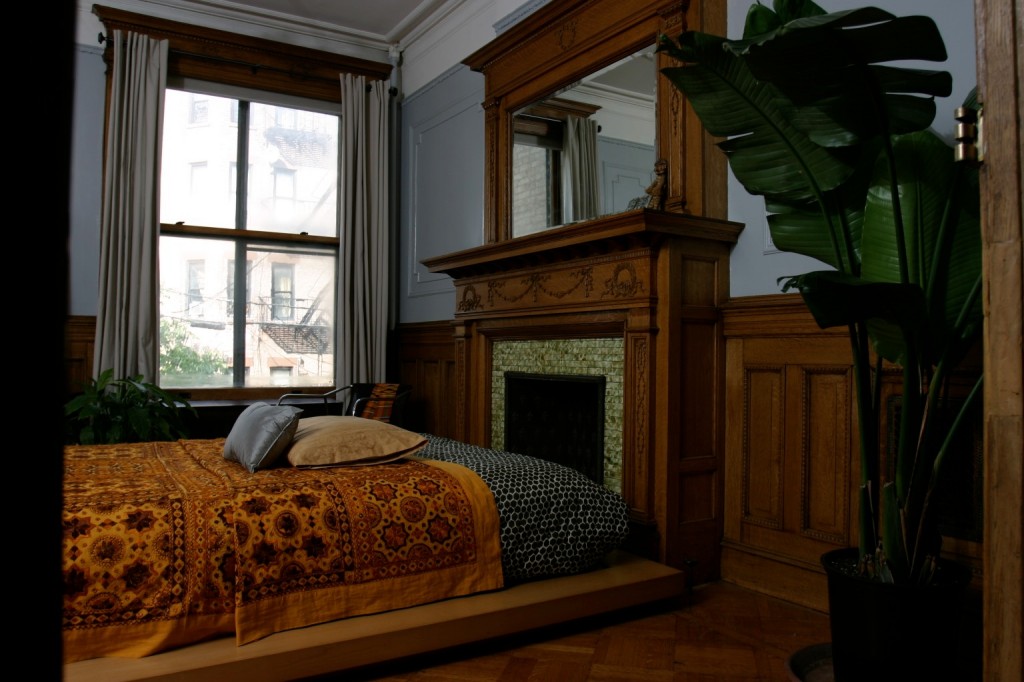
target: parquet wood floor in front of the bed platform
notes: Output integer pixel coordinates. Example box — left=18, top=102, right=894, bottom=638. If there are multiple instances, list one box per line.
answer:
left=327, top=583, right=829, bottom=682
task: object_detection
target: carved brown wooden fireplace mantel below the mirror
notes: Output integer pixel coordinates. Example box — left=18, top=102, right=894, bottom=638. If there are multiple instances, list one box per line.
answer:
left=424, top=209, right=741, bottom=579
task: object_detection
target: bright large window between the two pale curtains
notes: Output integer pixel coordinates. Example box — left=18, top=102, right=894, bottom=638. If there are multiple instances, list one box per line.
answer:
left=159, top=87, right=339, bottom=391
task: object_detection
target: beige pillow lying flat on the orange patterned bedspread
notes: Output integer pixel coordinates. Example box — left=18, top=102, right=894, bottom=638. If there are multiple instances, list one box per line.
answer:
left=287, top=416, right=427, bottom=467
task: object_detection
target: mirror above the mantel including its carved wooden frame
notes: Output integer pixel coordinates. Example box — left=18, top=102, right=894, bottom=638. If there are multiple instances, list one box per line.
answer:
left=464, top=0, right=726, bottom=244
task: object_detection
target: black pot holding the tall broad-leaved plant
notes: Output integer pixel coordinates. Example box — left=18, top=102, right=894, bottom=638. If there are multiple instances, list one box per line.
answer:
left=821, top=548, right=971, bottom=682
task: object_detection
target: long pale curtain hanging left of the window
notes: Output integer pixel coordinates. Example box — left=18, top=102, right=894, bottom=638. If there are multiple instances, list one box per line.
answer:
left=92, top=31, right=168, bottom=382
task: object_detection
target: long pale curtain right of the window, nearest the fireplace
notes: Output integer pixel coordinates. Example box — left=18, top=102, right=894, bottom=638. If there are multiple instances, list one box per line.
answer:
left=336, top=74, right=390, bottom=386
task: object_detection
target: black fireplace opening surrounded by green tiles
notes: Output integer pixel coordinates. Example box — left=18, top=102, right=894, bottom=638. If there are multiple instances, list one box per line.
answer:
left=505, top=372, right=605, bottom=484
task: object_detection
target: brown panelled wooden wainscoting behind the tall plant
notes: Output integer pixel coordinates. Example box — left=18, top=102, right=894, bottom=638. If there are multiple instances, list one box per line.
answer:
left=722, top=295, right=981, bottom=610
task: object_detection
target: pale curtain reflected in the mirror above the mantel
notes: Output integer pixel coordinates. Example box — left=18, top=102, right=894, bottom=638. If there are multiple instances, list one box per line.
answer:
left=562, top=115, right=600, bottom=222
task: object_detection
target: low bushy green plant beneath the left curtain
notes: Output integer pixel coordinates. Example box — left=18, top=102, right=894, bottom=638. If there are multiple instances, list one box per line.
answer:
left=65, top=370, right=196, bottom=445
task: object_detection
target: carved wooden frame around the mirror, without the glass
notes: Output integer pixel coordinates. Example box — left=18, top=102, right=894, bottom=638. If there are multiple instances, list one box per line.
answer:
left=463, top=0, right=727, bottom=244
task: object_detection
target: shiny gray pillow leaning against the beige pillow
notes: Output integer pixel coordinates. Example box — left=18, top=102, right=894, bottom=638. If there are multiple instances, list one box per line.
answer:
left=224, top=402, right=302, bottom=472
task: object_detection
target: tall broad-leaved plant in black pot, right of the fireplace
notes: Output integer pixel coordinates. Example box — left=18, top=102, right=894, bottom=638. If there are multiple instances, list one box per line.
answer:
left=658, top=0, right=982, bottom=681
